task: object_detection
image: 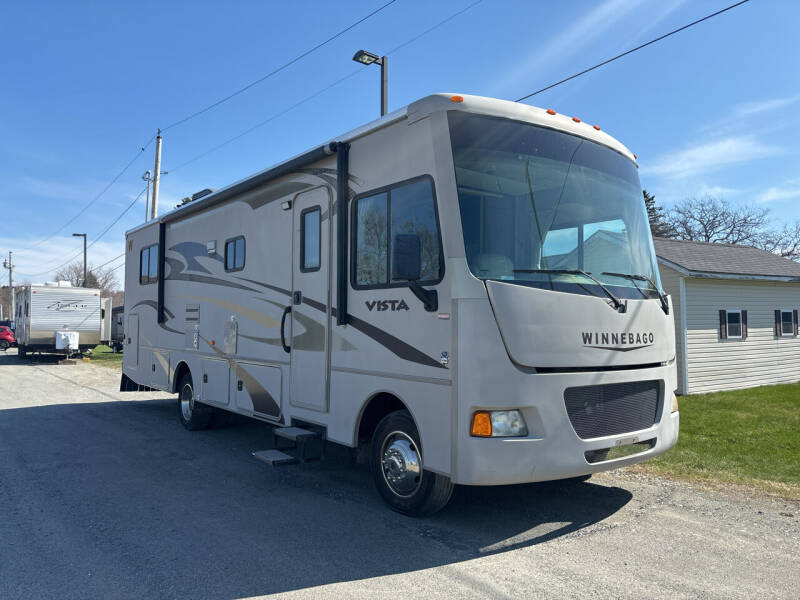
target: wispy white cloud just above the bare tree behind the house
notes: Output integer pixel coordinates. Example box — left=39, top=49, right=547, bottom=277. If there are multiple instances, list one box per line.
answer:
left=642, top=135, right=782, bottom=179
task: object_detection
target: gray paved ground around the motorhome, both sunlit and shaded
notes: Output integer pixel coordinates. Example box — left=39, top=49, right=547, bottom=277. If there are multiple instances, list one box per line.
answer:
left=0, top=350, right=800, bottom=600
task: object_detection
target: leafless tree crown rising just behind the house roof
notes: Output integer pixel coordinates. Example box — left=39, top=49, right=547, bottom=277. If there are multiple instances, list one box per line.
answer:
left=669, top=196, right=769, bottom=246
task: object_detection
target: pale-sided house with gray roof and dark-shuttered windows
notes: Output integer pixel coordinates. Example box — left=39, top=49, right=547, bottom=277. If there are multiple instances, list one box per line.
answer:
left=654, top=238, right=800, bottom=394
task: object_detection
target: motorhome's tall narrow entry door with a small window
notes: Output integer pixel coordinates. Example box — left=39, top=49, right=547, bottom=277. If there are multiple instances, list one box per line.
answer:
left=290, top=187, right=331, bottom=412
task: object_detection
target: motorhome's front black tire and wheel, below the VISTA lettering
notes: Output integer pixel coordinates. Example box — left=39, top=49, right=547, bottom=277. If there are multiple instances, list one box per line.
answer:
left=370, top=410, right=453, bottom=517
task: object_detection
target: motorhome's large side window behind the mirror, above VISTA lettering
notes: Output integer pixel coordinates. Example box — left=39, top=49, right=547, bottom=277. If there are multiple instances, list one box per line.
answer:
left=352, top=177, right=443, bottom=289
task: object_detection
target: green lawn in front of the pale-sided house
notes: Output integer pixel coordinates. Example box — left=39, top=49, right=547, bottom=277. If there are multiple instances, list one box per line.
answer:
left=636, top=384, right=800, bottom=499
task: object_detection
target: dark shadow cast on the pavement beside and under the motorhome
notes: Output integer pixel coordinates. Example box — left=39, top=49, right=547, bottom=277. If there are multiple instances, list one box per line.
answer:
left=0, top=376, right=631, bottom=598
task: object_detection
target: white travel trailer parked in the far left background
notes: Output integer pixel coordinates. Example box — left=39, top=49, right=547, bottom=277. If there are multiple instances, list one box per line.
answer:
left=16, top=281, right=101, bottom=357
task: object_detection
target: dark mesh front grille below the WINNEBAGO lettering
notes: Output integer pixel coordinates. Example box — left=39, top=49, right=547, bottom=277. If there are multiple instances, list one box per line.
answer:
left=564, top=380, right=664, bottom=440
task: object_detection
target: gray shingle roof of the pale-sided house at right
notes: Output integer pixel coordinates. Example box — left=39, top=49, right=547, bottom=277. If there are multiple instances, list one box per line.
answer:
left=653, top=238, right=800, bottom=278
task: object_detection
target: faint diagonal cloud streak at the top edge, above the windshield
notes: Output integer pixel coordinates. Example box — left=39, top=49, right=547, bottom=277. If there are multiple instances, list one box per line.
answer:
left=493, top=0, right=640, bottom=88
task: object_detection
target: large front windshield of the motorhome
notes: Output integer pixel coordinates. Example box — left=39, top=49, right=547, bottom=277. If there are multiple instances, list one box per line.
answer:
left=449, top=111, right=661, bottom=298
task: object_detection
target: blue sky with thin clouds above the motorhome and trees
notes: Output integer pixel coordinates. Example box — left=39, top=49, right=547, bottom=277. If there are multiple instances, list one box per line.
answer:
left=0, top=0, right=800, bottom=281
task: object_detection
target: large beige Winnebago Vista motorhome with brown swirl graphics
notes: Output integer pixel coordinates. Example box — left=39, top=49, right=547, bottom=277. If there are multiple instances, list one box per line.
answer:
left=121, top=94, right=678, bottom=514
